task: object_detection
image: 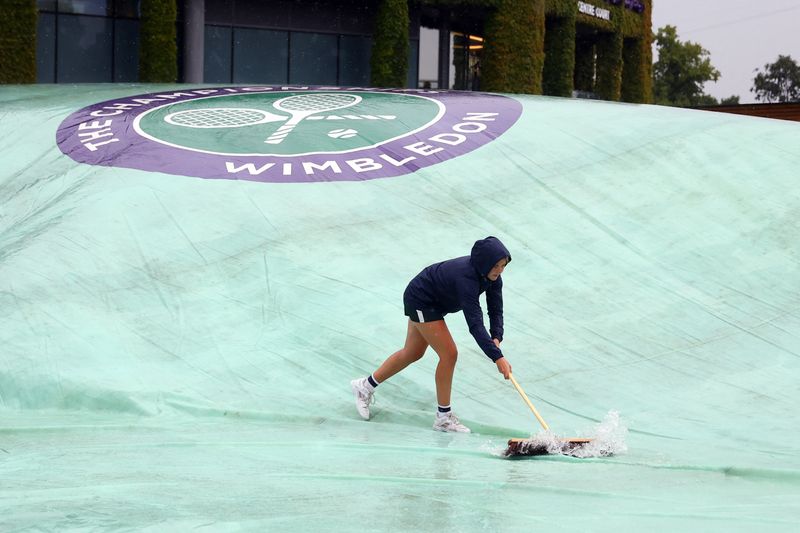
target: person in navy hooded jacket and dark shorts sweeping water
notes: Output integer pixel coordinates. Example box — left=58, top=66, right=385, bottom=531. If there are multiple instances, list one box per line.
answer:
left=350, top=237, right=511, bottom=433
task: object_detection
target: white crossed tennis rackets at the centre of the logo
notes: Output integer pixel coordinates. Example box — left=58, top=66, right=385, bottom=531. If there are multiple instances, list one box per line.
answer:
left=164, top=93, right=394, bottom=144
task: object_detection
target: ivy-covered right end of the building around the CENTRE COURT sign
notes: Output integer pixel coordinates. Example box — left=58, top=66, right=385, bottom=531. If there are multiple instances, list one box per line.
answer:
left=411, top=0, right=653, bottom=102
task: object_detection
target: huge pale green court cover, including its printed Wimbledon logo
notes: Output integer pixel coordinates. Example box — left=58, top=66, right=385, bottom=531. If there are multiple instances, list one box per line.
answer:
left=0, top=85, right=800, bottom=532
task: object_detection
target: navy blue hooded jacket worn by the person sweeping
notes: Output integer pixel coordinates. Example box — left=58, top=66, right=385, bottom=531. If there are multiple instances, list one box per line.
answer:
left=403, top=237, right=511, bottom=361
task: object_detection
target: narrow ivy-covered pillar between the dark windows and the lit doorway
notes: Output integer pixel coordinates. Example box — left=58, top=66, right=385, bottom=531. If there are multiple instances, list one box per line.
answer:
left=370, top=0, right=409, bottom=87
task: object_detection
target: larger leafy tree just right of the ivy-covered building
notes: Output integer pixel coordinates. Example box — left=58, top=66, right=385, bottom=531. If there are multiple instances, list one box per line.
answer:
left=653, top=26, right=720, bottom=107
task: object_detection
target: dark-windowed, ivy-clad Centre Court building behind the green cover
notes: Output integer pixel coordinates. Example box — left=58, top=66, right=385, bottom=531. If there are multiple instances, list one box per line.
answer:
left=6, top=0, right=652, bottom=102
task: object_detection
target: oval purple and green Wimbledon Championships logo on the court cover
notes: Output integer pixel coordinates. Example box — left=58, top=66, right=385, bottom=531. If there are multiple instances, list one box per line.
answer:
left=56, top=87, right=522, bottom=182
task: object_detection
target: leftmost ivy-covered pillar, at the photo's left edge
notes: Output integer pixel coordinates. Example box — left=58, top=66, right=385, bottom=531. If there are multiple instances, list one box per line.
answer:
left=0, top=0, right=38, bottom=83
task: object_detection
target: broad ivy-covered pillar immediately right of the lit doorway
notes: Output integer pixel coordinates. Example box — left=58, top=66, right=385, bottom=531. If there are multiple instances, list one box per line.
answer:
left=481, top=0, right=545, bottom=94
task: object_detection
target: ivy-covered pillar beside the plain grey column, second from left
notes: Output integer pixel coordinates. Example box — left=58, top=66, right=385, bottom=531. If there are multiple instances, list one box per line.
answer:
left=139, top=0, right=178, bottom=83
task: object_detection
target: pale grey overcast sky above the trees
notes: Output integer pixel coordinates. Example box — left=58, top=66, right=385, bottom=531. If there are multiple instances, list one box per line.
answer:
left=653, top=0, right=800, bottom=103
